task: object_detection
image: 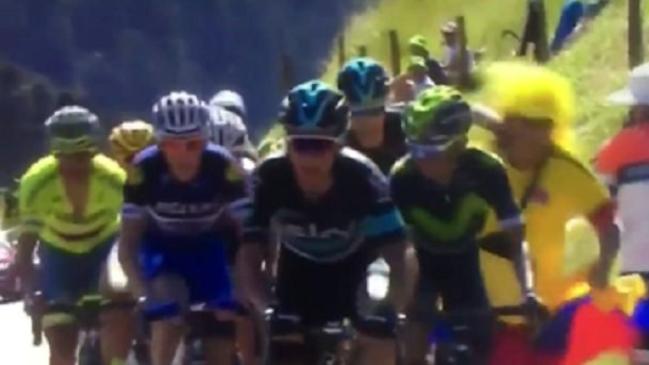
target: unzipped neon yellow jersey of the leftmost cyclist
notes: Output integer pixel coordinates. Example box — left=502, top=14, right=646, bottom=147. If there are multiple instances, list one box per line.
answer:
left=18, top=154, right=126, bottom=254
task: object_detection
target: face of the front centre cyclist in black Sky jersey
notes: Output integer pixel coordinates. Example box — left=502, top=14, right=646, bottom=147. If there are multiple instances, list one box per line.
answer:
left=288, top=138, right=339, bottom=192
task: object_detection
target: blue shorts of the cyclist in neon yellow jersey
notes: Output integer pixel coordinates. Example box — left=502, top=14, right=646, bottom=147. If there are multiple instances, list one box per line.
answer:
left=38, top=236, right=115, bottom=304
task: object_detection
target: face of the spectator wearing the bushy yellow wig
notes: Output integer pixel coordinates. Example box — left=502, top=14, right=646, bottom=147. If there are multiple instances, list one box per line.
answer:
left=496, top=116, right=552, bottom=169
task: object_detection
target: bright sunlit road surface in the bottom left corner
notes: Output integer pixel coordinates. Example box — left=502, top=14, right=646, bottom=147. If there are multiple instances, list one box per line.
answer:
left=0, top=303, right=48, bottom=365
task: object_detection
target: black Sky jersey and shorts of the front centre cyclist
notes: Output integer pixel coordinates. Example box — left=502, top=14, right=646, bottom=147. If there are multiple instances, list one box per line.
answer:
left=244, top=148, right=404, bottom=323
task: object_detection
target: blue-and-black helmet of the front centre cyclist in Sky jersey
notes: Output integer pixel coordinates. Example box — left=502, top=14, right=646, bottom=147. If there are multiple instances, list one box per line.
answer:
left=280, top=80, right=349, bottom=139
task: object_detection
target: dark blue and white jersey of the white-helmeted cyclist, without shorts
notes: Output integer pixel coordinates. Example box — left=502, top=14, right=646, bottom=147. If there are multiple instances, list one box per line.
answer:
left=122, top=144, right=246, bottom=236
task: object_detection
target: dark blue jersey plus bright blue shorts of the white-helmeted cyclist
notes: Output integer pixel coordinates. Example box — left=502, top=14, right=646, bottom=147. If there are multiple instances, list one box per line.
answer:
left=122, top=144, right=245, bottom=319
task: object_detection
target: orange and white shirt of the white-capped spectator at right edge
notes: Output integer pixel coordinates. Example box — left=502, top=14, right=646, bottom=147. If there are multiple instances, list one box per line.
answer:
left=595, top=123, right=649, bottom=273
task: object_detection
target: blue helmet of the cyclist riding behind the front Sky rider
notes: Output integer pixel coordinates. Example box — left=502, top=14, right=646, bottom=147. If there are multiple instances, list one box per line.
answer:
left=338, top=58, right=388, bottom=113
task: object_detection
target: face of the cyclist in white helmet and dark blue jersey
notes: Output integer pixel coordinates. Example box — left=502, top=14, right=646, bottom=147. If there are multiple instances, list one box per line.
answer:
left=159, top=138, right=207, bottom=181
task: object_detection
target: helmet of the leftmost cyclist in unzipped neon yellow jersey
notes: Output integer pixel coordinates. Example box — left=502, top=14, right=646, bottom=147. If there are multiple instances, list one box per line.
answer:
left=45, top=106, right=100, bottom=154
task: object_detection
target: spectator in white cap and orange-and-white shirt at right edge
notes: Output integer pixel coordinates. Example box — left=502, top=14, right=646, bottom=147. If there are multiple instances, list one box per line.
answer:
left=595, top=63, right=649, bottom=290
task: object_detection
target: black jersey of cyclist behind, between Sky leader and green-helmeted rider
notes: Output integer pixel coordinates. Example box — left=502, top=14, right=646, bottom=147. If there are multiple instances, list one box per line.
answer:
left=347, top=110, right=406, bottom=174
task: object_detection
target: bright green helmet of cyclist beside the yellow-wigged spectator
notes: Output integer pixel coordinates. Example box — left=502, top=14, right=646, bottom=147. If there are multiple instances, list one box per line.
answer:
left=403, top=86, right=472, bottom=157
